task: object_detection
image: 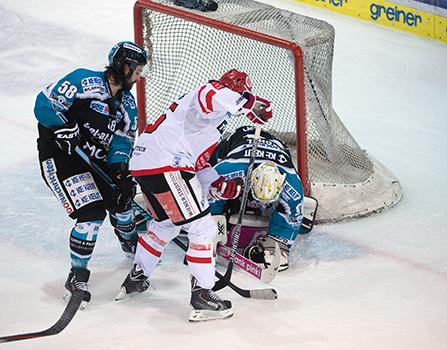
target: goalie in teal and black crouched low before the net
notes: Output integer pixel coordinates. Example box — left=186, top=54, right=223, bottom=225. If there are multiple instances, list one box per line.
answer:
left=210, top=126, right=316, bottom=271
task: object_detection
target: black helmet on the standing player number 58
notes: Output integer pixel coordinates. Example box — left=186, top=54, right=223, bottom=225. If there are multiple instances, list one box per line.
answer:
left=109, top=41, right=148, bottom=72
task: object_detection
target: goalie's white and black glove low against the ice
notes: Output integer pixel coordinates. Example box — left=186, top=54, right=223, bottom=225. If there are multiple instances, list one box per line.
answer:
left=242, top=235, right=289, bottom=271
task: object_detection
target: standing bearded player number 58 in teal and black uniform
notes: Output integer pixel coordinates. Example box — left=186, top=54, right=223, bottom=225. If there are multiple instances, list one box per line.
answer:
left=34, top=42, right=148, bottom=306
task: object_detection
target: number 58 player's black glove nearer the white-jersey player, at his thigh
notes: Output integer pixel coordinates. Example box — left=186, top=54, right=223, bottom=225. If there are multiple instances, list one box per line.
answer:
left=110, top=163, right=137, bottom=213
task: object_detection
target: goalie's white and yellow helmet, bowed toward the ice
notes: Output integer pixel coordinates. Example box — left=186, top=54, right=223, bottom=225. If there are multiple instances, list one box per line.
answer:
left=251, top=161, right=286, bottom=203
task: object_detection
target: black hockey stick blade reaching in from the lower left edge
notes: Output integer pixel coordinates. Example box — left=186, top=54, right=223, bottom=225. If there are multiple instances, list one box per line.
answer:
left=0, top=291, right=84, bottom=344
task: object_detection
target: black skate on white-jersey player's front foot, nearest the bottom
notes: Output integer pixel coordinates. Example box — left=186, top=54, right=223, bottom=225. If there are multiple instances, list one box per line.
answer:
left=189, top=277, right=233, bottom=322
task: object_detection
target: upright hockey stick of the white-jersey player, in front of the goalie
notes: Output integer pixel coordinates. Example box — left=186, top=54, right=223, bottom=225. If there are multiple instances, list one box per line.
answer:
left=213, top=124, right=262, bottom=291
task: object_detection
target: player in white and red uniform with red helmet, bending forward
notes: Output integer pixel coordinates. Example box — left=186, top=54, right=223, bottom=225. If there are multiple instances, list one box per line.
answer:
left=116, top=69, right=272, bottom=321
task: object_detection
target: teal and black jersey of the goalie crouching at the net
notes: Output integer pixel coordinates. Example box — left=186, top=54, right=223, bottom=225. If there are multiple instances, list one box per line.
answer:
left=210, top=126, right=304, bottom=246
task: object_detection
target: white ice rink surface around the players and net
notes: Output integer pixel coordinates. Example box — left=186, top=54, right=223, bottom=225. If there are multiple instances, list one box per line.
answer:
left=0, top=0, right=447, bottom=350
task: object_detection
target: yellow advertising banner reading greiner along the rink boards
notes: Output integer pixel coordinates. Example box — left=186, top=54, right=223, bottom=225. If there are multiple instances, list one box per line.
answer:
left=294, top=0, right=447, bottom=43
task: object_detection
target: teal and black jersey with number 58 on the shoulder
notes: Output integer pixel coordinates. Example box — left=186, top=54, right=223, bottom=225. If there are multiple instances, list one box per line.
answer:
left=34, top=68, right=138, bottom=164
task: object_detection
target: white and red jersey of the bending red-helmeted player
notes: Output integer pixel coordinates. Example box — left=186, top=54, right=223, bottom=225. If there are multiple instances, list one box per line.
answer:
left=130, top=81, right=247, bottom=176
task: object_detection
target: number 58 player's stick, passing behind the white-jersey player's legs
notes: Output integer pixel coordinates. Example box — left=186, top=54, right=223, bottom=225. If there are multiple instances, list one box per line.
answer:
left=75, top=147, right=278, bottom=300
